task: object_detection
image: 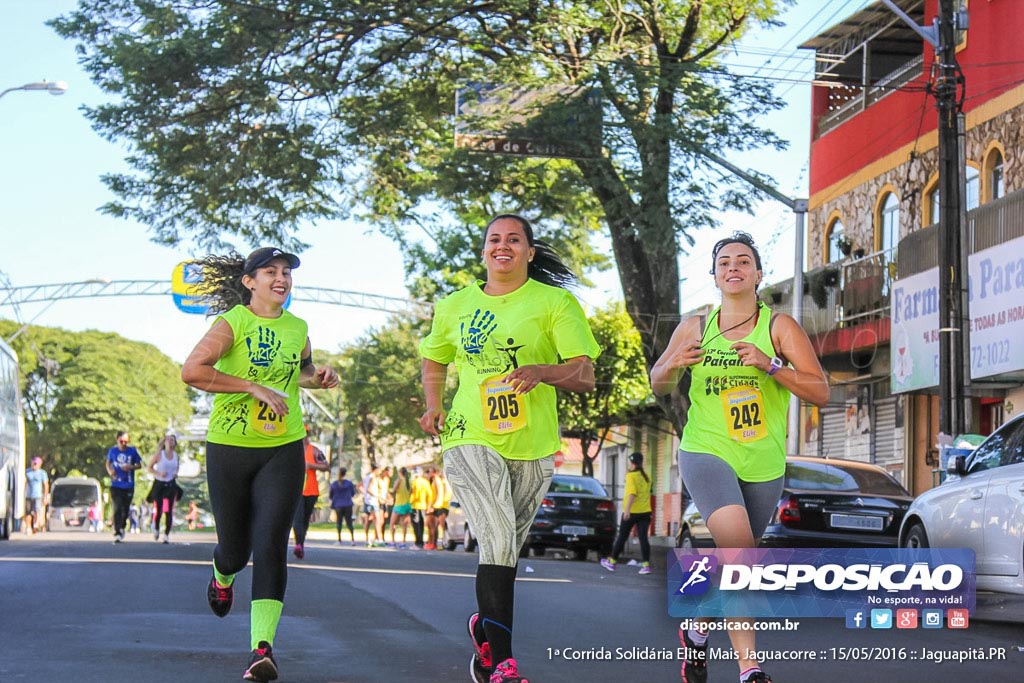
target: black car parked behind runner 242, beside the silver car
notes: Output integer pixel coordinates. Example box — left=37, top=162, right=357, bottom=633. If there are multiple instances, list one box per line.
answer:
left=676, top=457, right=913, bottom=548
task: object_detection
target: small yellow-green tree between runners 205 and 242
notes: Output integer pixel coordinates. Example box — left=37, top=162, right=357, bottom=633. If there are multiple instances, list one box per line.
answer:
left=558, top=303, right=651, bottom=476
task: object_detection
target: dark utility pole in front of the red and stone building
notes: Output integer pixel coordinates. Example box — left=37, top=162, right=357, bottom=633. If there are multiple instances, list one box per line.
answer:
left=882, top=0, right=971, bottom=436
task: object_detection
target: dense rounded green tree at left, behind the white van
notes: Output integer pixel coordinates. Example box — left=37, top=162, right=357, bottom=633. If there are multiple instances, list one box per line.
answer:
left=0, top=321, right=191, bottom=479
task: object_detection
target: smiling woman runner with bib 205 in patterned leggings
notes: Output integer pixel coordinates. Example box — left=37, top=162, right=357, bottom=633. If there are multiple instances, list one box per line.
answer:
left=420, top=214, right=600, bottom=683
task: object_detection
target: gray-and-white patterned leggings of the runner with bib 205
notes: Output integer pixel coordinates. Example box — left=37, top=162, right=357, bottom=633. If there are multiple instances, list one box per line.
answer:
left=444, top=444, right=555, bottom=567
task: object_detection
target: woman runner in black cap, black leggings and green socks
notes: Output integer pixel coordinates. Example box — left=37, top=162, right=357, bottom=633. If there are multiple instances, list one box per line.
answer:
left=181, top=247, right=338, bottom=681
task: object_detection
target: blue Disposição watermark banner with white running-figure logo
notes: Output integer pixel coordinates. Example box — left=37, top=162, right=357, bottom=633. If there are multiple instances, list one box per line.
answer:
left=667, top=548, right=976, bottom=618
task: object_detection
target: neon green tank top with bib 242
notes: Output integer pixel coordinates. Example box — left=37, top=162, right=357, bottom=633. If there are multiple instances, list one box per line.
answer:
left=679, top=303, right=790, bottom=481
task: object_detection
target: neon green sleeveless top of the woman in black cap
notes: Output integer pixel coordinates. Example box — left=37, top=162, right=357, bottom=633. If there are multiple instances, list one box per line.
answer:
left=206, top=305, right=307, bottom=449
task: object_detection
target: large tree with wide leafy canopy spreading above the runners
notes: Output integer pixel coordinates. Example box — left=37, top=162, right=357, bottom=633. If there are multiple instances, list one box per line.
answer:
left=52, top=0, right=790, bottom=428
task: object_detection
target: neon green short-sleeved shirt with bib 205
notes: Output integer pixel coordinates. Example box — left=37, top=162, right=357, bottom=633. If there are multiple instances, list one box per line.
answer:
left=420, top=280, right=600, bottom=460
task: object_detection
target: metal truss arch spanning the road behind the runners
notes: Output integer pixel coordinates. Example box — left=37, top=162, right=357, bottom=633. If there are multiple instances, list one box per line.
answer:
left=0, top=280, right=431, bottom=316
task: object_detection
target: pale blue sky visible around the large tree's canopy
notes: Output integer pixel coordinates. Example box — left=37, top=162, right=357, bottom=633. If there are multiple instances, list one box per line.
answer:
left=0, top=0, right=869, bottom=361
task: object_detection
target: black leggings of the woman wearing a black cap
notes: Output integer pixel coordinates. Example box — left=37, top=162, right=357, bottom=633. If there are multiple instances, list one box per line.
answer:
left=206, top=440, right=306, bottom=602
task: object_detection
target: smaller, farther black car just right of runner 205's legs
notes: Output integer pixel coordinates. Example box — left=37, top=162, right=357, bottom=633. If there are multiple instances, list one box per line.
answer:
left=520, top=474, right=615, bottom=560
